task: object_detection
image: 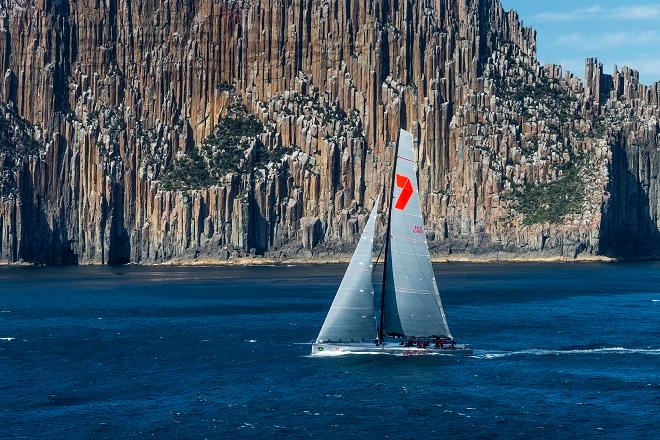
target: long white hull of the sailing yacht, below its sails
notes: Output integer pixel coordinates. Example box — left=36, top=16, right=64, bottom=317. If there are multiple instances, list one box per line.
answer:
left=312, top=343, right=473, bottom=356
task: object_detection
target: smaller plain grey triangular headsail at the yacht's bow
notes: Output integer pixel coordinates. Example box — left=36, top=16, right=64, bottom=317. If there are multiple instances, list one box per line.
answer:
left=316, top=202, right=378, bottom=342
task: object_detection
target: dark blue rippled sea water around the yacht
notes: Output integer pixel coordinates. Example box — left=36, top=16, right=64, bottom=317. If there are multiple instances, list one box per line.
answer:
left=0, top=263, right=660, bottom=439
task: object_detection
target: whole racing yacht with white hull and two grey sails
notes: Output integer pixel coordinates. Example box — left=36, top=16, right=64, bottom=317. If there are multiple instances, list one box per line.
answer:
left=312, top=130, right=472, bottom=356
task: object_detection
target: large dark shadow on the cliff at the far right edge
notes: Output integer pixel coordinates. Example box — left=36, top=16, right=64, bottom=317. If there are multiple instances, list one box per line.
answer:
left=600, top=139, right=660, bottom=260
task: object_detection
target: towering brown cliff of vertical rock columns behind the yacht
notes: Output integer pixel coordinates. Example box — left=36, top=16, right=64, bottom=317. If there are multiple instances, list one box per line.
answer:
left=0, top=0, right=660, bottom=264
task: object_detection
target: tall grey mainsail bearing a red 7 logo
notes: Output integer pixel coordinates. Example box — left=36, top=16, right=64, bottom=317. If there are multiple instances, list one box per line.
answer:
left=382, top=130, right=451, bottom=337
